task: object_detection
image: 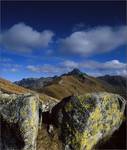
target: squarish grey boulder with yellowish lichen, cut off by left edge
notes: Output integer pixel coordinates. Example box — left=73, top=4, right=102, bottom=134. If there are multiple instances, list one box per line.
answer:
left=0, top=93, right=39, bottom=150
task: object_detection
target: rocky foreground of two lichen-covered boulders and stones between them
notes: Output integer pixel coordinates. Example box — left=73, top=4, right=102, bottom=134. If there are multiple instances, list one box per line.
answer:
left=0, top=92, right=125, bottom=150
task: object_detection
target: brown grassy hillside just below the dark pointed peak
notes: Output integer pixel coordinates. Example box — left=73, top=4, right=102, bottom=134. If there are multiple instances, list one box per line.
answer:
left=38, top=75, right=111, bottom=99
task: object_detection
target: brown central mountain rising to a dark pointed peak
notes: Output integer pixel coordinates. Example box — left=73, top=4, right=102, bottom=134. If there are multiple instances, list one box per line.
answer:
left=15, top=69, right=106, bottom=99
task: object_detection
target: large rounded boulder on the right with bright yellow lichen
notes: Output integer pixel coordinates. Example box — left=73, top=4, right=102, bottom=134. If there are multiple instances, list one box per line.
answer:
left=52, top=92, right=125, bottom=150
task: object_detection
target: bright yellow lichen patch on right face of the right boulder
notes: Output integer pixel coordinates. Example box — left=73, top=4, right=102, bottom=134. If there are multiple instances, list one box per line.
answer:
left=78, top=94, right=123, bottom=150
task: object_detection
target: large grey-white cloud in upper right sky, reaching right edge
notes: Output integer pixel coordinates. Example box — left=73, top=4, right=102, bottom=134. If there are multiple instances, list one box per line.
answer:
left=60, top=26, right=127, bottom=56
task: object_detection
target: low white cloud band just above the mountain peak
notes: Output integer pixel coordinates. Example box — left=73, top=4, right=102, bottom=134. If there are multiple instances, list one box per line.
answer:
left=26, top=60, right=127, bottom=76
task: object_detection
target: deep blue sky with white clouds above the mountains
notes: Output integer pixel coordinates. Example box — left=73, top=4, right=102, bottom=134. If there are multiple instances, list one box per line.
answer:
left=0, top=1, right=127, bottom=81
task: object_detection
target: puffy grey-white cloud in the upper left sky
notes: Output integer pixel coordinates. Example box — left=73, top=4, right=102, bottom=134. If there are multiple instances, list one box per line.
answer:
left=0, top=23, right=54, bottom=52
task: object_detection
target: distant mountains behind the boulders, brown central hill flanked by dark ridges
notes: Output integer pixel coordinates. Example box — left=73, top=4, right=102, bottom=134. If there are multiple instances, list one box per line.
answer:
left=15, top=68, right=126, bottom=99
